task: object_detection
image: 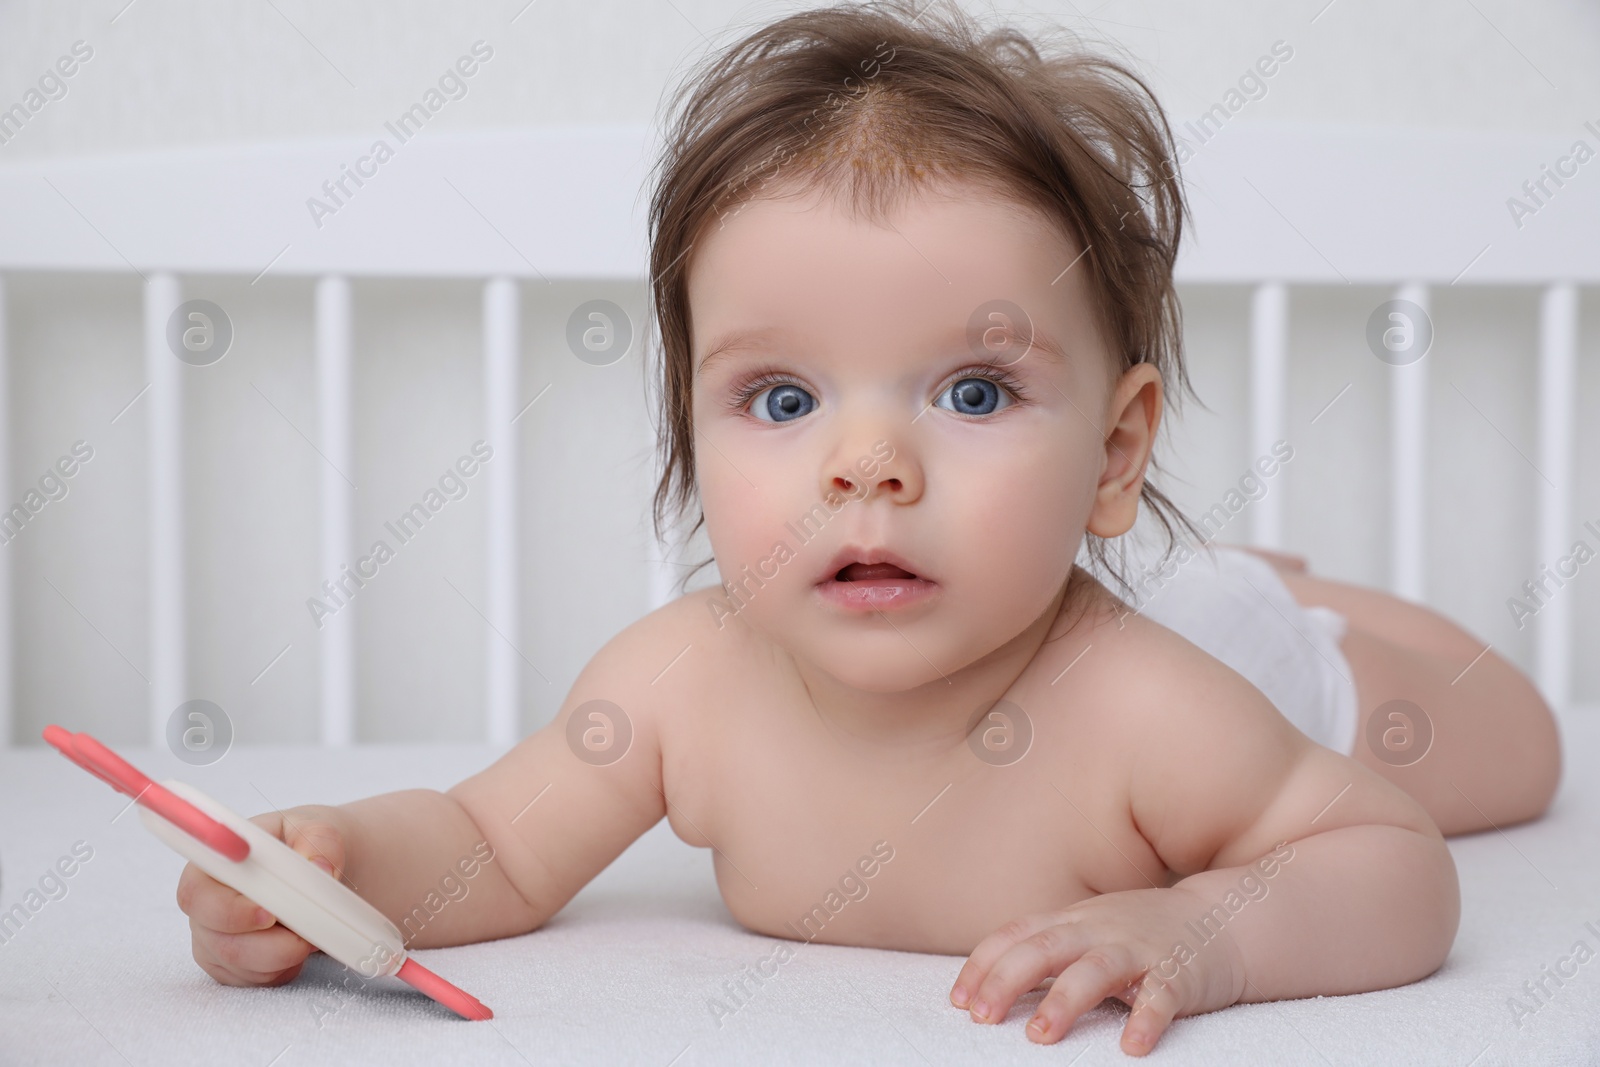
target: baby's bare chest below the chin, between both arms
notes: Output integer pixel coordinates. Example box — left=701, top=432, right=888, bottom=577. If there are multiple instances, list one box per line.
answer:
left=662, top=671, right=1166, bottom=953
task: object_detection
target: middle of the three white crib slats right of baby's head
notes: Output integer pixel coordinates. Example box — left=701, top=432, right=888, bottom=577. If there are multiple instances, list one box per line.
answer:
left=1389, top=282, right=1437, bottom=601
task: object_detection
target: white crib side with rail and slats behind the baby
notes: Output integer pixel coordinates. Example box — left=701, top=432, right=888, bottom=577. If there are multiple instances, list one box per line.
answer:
left=0, top=123, right=1600, bottom=745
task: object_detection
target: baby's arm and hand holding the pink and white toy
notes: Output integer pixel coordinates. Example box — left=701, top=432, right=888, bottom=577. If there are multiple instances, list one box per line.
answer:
left=178, top=605, right=674, bottom=985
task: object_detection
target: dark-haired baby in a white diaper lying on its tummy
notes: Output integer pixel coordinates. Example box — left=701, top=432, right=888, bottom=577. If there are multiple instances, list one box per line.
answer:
left=178, top=2, right=1560, bottom=1054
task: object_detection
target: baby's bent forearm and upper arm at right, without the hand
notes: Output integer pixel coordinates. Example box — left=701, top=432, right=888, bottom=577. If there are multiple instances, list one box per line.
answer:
left=1134, top=683, right=1461, bottom=1001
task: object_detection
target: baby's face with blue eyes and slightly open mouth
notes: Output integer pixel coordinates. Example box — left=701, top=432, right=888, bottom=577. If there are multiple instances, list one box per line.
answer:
left=690, top=181, right=1112, bottom=691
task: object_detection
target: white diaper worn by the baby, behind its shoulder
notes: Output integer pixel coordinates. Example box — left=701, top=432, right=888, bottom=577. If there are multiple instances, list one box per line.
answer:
left=1102, top=542, right=1360, bottom=755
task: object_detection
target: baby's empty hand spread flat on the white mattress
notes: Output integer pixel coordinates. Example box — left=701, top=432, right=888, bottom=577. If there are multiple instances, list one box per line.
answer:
left=950, top=888, right=1245, bottom=1056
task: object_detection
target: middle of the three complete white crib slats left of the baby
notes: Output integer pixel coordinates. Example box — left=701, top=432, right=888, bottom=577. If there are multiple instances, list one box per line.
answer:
left=315, top=275, right=360, bottom=747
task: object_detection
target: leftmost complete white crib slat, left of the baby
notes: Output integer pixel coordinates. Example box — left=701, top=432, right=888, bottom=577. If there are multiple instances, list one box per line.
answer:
left=144, top=272, right=186, bottom=747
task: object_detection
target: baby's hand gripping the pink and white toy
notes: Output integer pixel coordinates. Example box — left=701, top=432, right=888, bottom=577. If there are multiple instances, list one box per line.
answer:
left=178, top=806, right=344, bottom=985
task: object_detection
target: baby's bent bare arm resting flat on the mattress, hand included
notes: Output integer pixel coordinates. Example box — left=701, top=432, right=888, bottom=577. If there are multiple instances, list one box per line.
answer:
left=952, top=630, right=1461, bottom=1054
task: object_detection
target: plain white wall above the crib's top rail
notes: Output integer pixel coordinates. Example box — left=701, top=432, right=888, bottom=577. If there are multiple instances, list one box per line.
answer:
left=0, top=0, right=1600, bottom=158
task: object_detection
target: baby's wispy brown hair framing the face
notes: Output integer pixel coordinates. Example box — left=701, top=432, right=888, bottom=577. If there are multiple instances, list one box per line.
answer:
left=636, top=0, right=1203, bottom=604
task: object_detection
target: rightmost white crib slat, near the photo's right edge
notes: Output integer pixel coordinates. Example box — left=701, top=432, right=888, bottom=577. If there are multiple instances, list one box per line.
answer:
left=1534, top=282, right=1578, bottom=712
